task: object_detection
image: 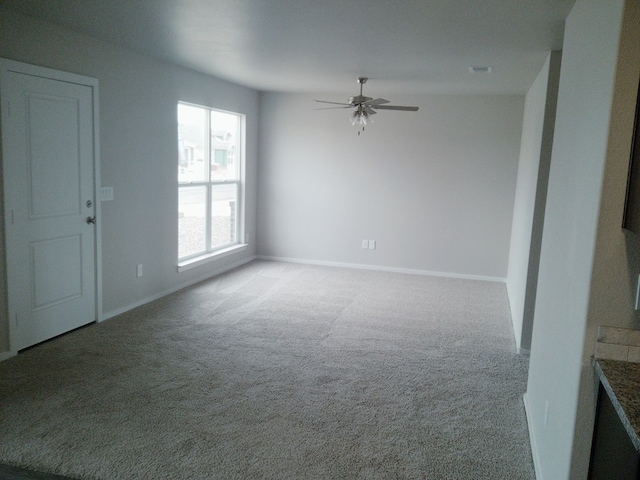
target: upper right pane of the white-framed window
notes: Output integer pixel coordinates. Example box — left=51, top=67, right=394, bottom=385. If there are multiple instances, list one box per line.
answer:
left=211, top=111, right=240, bottom=180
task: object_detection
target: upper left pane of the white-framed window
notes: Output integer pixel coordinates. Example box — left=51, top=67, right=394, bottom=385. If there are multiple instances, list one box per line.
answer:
left=178, top=103, right=207, bottom=182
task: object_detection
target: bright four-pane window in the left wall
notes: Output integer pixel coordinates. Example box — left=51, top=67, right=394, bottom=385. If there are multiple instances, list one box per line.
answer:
left=178, top=103, right=244, bottom=264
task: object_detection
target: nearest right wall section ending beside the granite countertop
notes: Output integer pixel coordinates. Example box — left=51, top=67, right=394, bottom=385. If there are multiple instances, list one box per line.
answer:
left=525, top=0, right=640, bottom=480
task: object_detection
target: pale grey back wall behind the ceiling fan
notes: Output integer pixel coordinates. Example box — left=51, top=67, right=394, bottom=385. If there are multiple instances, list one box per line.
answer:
left=258, top=92, right=524, bottom=278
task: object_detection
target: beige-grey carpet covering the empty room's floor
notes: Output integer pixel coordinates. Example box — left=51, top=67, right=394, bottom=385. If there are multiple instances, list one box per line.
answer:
left=0, top=261, right=535, bottom=480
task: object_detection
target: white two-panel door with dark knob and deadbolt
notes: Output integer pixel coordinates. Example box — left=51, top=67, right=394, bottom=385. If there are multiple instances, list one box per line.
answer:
left=1, top=62, right=97, bottom=351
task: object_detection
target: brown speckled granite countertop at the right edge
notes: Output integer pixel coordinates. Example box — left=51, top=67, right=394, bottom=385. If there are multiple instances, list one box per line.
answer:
left=594, top=359, right=640, bottom=451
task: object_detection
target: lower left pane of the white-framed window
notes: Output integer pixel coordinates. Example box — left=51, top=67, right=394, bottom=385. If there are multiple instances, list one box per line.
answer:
left=178, top=187, right=207, bottom=258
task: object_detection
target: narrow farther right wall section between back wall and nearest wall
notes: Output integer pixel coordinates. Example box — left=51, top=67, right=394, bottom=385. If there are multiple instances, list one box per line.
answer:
left=507, top=51, right=561, bottom=353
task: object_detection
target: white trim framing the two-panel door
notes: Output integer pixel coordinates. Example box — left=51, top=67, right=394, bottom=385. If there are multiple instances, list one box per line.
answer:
left=0, top=58, right=103, bottom=348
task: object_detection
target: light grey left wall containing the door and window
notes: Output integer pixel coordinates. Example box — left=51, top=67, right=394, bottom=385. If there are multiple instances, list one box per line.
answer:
left=0, top=8, right=258, bottom=350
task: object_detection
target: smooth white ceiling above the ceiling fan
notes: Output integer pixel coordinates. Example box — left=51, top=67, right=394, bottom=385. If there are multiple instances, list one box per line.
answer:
left=0, top=0, right=575, bottom=95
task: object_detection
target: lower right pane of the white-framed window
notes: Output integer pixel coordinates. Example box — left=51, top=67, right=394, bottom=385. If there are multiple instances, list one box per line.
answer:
left=211, top=183, right=238, bottom=248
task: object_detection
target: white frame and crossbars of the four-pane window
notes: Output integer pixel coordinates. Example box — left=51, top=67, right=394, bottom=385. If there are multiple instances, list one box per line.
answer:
left=176, top=102, right=247, bottom=272
